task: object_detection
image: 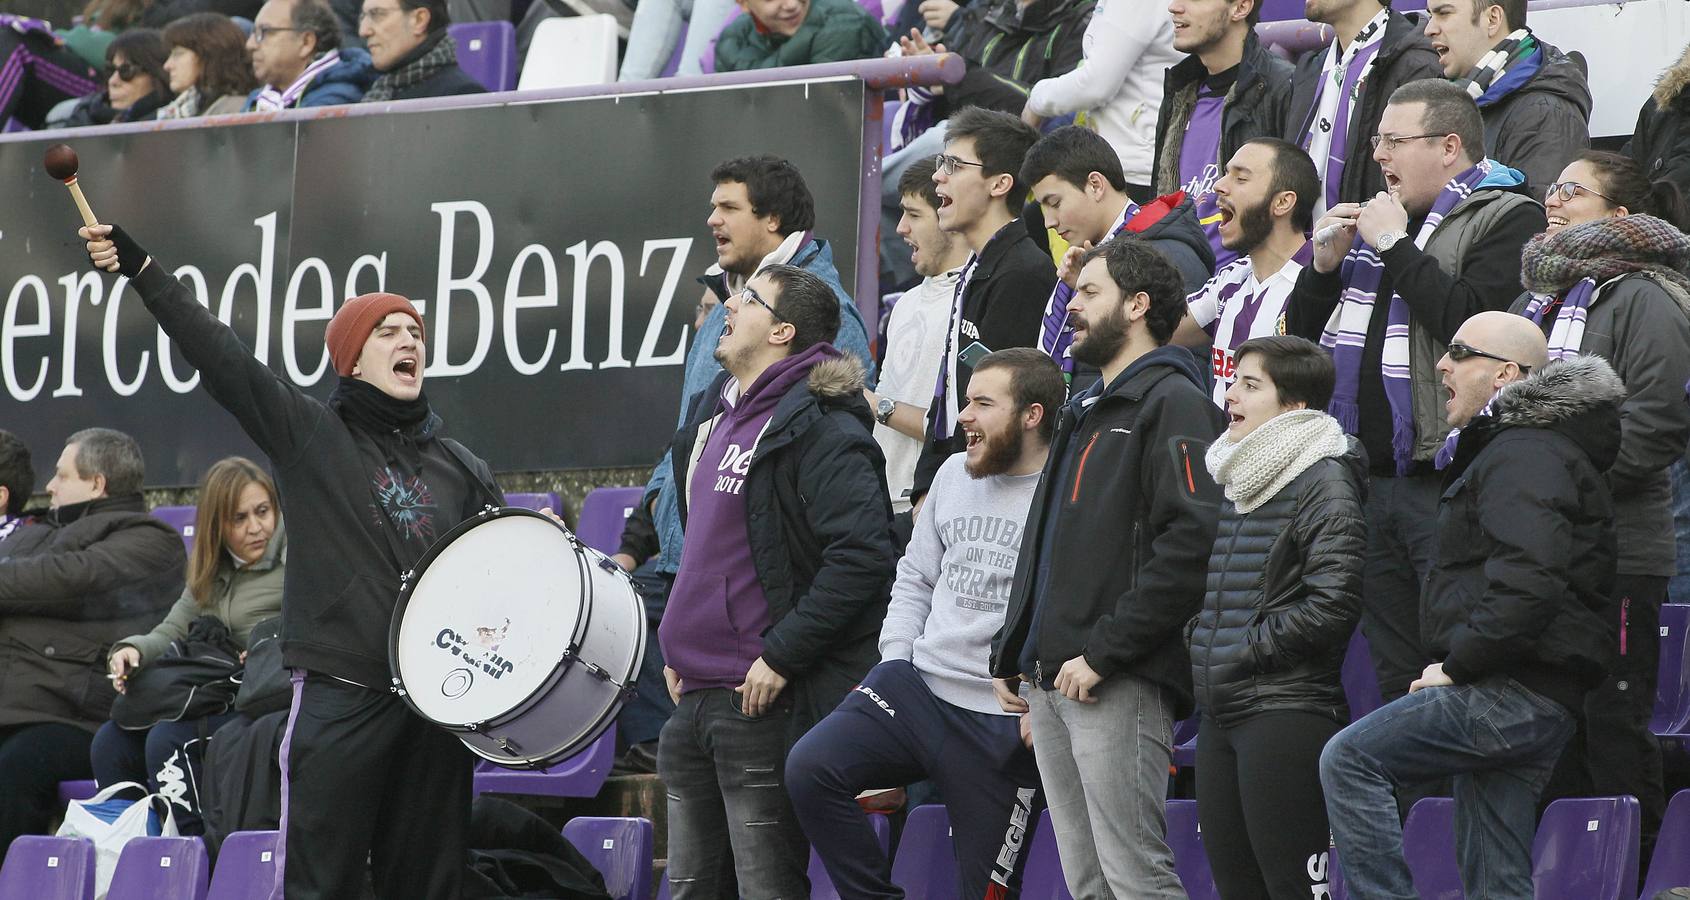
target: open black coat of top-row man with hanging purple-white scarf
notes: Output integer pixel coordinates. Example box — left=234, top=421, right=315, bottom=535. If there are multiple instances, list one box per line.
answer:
left=1284, top=10, right=1443, bottom=203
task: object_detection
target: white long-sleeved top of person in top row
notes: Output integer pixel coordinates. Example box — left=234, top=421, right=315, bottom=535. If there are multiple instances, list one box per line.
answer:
left=1028, top=0, right=1185, bottom=184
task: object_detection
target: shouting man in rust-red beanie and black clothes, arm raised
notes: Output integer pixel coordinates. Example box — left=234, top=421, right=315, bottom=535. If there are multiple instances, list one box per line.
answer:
left=79, top=225, right=504, bottom=900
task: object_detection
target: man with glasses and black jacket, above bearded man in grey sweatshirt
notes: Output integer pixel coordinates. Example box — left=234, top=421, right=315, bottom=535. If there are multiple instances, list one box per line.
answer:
left=909, top=106, right=1056, bottom=507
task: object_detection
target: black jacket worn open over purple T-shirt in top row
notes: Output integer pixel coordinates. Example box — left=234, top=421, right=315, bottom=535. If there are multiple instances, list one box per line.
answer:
left=1151, top=30, right=1291, bottom=196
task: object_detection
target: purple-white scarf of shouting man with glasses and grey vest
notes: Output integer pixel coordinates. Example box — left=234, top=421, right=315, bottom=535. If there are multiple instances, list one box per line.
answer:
left=1320, top=159, right=1491, bottom=474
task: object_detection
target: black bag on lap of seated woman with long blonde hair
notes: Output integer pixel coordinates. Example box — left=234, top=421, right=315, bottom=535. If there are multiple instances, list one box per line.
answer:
left=112, top=616, right=242, bottom=731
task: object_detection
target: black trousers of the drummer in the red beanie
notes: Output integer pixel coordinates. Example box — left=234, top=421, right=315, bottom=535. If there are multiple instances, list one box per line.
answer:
left=272, top=670, right=473, bottom=900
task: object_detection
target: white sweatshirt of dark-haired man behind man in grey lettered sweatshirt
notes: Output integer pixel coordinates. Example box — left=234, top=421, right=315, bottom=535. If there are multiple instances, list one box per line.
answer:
left=874, top=267, right=962, bottom=512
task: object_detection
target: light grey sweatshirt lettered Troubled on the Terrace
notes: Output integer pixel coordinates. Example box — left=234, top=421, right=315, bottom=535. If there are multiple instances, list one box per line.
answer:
left=880, top=453, right=1039, bottom=714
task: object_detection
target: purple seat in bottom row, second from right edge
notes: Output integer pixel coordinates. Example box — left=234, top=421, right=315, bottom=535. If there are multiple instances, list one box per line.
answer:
left=1531, top=797, right=1643, bottom=900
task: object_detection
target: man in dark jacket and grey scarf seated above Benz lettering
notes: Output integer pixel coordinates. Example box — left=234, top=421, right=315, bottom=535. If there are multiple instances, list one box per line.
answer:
left=358, top=0, right=487, bottom=103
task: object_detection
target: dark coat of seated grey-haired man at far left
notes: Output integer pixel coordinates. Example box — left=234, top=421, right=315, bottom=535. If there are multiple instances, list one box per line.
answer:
left=0, top=496, right=183, bottom=731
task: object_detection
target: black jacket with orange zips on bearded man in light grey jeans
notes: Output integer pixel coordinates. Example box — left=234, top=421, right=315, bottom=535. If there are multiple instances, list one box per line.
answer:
left=992, top=346, right=1222, bottom=718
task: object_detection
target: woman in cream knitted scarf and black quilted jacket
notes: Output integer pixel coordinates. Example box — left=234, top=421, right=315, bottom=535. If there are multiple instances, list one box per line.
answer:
left=1188, top=336, right=1367, bottom=900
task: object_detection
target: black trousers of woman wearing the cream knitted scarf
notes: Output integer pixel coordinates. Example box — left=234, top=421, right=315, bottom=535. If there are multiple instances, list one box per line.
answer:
left=1197, top=713, right=1342, bottom=900
